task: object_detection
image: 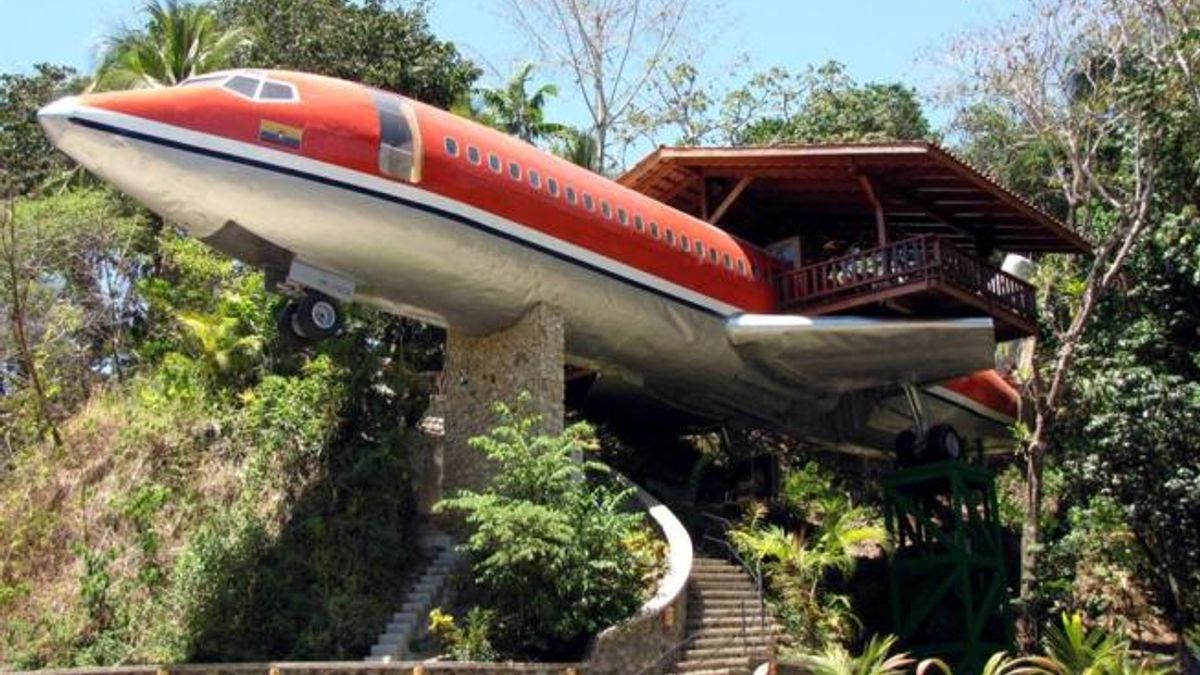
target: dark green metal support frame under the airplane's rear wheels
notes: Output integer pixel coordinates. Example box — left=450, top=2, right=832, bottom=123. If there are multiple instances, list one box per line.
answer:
left=883, top=461, right=1013, bottom=673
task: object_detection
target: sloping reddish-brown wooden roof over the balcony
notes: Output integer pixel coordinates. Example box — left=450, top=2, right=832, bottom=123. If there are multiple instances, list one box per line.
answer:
left=618, top=142, right=1090, bottom=252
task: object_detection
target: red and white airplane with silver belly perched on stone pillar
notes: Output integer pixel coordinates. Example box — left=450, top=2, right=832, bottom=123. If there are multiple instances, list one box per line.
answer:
left=38, top=70, right=1051, bottom=456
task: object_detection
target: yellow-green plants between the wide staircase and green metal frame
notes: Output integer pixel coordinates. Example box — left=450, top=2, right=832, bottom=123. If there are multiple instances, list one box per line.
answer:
left=728, top=462, right=887, bottom=647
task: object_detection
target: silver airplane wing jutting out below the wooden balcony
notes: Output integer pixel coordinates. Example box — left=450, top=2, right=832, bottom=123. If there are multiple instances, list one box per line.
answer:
left=726, top=315, right=996, bottom=393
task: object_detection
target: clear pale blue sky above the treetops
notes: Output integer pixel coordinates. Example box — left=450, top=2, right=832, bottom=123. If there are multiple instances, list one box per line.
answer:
left=0, top=0, right=1019, bottom=136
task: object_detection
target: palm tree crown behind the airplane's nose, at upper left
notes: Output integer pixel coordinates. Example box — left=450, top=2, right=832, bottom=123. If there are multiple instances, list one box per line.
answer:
left=91, top=0, right=251, bottom=91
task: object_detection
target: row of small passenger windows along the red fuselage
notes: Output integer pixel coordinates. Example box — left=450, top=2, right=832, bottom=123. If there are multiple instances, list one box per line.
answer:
left=445, top=136, right=761, bottom=279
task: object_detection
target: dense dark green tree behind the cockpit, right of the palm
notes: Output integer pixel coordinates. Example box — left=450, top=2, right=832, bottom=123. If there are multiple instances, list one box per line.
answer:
left=215, top=0, right=479, bottom=108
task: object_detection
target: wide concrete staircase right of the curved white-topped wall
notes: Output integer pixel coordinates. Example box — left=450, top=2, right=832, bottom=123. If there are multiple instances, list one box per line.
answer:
left=667, top=556, right=782, bottom=675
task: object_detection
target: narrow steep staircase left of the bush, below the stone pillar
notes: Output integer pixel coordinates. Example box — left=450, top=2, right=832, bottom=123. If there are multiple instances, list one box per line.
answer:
left=365, top=531, right=461, bottom=662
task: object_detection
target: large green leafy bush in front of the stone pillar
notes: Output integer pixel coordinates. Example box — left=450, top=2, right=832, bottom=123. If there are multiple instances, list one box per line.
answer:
left=438, top=405, right=655, bottom=658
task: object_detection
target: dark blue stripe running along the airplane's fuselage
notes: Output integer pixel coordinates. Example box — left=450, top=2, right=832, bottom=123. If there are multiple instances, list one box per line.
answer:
left=70, top=117, right=726, bottom=318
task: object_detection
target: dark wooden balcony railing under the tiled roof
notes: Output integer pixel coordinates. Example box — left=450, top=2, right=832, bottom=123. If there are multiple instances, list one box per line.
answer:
left=776, top=234, right=1034, bottom=321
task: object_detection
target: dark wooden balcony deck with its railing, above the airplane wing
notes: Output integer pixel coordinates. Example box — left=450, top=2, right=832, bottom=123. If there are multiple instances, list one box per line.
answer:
left=776, top=235, right=1037, bottom=340
